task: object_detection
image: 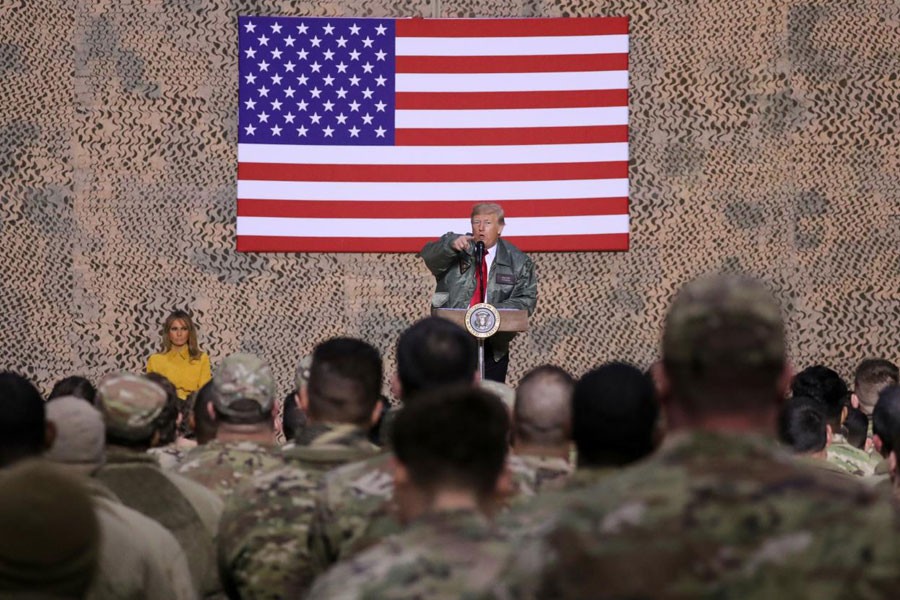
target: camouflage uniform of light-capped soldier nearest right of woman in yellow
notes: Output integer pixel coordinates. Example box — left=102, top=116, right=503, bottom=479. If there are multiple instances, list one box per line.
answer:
left=175, top=440, right=284, bottom=499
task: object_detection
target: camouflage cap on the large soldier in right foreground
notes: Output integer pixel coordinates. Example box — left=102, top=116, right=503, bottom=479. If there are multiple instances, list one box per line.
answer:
left=663, top=275, right=785, bottom=367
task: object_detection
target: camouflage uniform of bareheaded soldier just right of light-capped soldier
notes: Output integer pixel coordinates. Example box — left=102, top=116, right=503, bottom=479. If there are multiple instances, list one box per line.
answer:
left=219, top=425, right=379, bottom=600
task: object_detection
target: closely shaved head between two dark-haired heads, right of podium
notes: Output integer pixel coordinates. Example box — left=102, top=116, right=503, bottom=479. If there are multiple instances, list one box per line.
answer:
left=513, top=365, right=575, bottom=446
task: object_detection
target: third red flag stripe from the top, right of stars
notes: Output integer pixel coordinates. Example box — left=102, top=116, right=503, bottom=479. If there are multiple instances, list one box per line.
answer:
left=395, top=90, right=628, bottom=110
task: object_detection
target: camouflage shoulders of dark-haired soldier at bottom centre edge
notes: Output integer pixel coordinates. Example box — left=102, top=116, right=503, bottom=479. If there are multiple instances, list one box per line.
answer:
left=309, top=511, right=512, bottom=600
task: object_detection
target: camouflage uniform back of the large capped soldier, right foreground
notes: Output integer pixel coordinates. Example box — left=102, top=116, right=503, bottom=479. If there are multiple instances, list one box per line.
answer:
left=491, top=433, right=900, bottom=600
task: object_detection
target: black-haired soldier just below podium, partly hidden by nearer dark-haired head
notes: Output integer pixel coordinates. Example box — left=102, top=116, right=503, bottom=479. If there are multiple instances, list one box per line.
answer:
left=310, top=317, right=478, bottom=572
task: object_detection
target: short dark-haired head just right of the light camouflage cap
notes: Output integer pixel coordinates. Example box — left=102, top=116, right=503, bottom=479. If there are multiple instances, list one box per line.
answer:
left=306, top=338, right=382, bottom=426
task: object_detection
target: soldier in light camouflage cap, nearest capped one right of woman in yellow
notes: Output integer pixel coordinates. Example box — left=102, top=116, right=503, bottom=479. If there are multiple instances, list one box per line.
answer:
left=176, top=353, right=284, bottom=499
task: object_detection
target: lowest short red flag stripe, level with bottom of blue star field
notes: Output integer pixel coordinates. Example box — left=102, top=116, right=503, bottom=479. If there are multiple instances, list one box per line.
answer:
left=394, top=125, right=628, bottom=146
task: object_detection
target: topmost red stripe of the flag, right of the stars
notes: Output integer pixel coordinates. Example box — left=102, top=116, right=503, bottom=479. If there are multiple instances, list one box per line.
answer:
left=396, top=17, right=628, bottom=37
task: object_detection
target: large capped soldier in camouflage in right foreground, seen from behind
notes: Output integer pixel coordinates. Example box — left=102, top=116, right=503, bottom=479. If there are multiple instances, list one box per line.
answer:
left=493, top=276, right=900, bottom=599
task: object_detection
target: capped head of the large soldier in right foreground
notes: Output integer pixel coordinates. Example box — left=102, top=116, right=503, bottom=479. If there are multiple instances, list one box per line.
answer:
left=662, top=275, right=785, bottom=415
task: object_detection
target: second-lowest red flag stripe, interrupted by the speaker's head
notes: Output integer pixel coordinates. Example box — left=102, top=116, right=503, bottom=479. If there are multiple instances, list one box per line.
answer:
left=237, top=198, right=628, bottom=219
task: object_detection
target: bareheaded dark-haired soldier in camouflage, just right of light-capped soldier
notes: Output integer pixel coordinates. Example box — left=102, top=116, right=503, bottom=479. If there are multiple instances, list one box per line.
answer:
left=219, top=338, right=382, bottom=600
